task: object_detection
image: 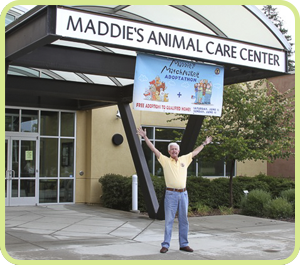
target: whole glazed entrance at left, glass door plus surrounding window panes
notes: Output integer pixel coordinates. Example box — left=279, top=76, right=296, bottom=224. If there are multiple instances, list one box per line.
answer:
left=5, top=107, right=76, bottom=206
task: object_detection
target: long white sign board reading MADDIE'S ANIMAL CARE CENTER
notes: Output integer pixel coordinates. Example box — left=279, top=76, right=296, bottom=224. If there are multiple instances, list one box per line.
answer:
left=56, top=8, right=286, bottom=72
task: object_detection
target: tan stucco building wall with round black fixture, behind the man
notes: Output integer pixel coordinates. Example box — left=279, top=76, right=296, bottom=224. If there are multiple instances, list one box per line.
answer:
left=75, top=106, right=267, bottom=203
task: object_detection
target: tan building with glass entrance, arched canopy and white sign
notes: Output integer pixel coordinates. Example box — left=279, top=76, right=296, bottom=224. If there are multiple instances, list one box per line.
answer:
left=5, top=6, right=290, bottom=216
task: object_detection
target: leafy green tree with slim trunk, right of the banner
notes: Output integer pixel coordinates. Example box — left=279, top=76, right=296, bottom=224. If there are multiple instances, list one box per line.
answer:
left=171, top=80, right=294, bottom=206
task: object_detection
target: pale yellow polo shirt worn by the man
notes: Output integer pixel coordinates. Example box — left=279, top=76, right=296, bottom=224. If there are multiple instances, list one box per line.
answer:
left=158, top=152, right=193, bottom=189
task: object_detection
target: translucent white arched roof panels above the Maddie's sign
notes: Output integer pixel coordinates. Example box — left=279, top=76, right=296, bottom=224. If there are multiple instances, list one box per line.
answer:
left=70, top=5, right=291, bottom=50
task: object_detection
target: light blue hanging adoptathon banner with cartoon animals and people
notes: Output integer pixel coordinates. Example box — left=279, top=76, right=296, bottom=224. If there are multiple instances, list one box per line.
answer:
left=133, top=54, right=224, bottom=116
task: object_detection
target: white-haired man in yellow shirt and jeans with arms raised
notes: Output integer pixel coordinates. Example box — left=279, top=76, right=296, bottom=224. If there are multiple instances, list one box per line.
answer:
left=137, top=128, right=212, bottom=253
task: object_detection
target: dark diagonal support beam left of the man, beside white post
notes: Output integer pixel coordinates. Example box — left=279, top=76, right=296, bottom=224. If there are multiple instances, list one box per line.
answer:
left=118, top=103, right=159, bottom=219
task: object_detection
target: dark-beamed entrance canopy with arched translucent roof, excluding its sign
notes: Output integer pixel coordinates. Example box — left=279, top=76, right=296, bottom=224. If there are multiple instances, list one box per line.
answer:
left=6, top=5, right=291, bottom=110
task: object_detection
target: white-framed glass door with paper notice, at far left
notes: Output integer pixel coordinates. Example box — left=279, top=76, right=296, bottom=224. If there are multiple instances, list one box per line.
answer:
left=5, top=137, right=38, bottom=206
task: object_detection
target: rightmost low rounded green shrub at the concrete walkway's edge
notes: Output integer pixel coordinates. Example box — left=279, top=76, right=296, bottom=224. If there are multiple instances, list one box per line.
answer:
left=265, top=198, right=294, bottom=219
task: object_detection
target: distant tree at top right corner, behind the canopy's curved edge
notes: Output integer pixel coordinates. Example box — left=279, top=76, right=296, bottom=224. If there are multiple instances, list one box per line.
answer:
left=262, top=5, right=295, bottom=71
